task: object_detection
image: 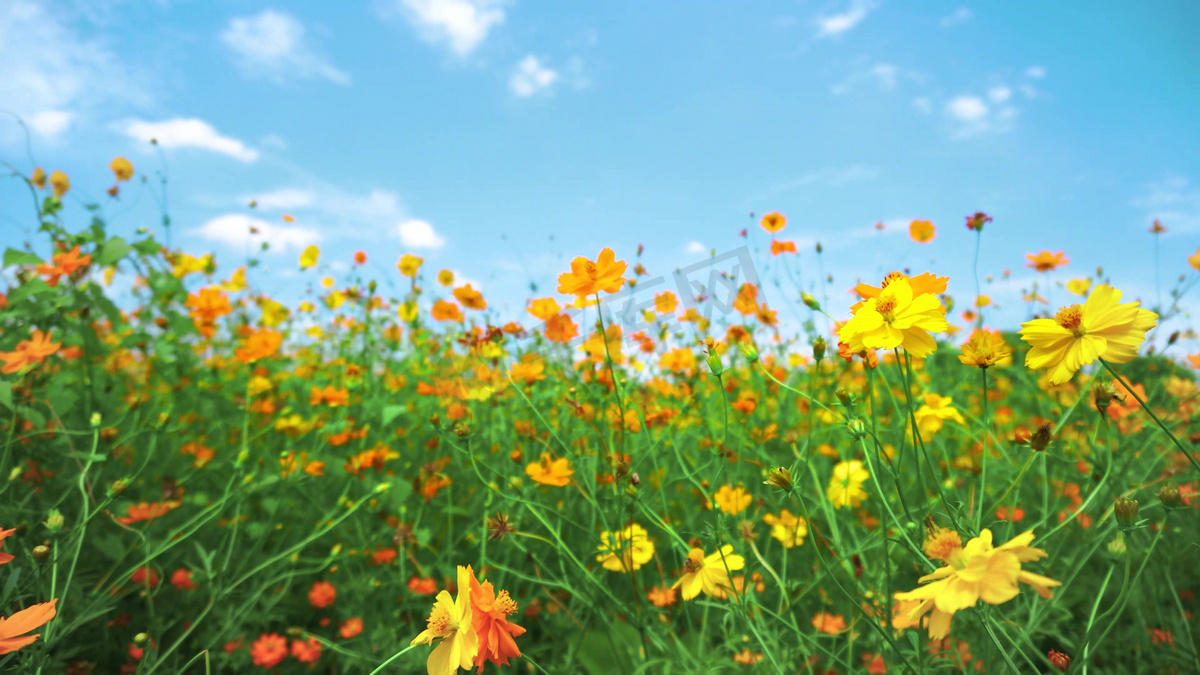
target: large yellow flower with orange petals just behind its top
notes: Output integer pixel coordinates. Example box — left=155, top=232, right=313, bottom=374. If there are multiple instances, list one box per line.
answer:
left=838, top=276, right=949, bottom=357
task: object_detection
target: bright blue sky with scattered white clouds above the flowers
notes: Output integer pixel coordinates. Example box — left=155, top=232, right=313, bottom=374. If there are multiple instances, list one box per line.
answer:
left=0, top=0, right=1200, bottom=345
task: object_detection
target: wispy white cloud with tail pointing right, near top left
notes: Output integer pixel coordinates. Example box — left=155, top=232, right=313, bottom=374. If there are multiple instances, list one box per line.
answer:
left=221, top=10, right=350, bottom=85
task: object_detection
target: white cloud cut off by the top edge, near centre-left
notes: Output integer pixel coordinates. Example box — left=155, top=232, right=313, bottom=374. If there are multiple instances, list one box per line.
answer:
left=380, top=0, right=504, bottom=56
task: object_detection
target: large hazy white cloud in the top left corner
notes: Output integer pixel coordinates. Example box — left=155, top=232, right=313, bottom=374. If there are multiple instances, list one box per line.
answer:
left=0, top=0, right=150, bottom=143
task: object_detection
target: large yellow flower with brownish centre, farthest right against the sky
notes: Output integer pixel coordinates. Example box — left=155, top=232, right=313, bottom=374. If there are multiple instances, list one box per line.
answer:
left=1021, top=283, right=1158, bottom=384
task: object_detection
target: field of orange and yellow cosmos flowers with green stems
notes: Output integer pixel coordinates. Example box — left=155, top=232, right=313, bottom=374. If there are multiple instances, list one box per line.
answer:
left=0, top=157, right=1200, bottom=675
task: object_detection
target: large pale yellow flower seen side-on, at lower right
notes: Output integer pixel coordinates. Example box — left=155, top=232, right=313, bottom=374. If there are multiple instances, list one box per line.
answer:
left=895, top=530, right=1062, bottom=640
